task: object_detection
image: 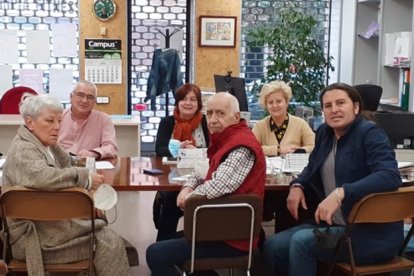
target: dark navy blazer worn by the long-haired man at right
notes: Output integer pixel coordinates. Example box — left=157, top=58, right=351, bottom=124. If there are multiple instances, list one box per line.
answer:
left=292, top=117, right=403, bottom=262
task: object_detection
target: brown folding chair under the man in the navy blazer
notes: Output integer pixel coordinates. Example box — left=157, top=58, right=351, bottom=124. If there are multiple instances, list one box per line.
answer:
left=328, top=187, right=414, bottom=275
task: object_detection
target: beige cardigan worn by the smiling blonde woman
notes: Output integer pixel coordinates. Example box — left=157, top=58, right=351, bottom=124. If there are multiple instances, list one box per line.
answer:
left=253, top=114, right=315, bottom=156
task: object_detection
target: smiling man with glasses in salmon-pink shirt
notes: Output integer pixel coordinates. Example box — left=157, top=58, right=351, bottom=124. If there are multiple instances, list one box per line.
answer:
left=58, top=80, right=118, bottom=159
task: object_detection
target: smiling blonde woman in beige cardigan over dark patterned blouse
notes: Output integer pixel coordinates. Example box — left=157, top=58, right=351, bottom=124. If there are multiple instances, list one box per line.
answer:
left=253, top=81, right=315, bottom=156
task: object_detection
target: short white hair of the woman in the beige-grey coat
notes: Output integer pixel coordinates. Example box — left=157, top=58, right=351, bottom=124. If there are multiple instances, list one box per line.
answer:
left=19, top=94, right=63, bottom=118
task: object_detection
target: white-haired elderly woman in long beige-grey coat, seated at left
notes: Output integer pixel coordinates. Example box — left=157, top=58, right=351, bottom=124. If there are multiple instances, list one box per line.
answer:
left=3, top=95, right=129, bottom=276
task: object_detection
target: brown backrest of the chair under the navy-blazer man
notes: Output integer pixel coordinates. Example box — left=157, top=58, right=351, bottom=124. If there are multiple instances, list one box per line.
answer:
left=348, top=187, right=414, bottom=223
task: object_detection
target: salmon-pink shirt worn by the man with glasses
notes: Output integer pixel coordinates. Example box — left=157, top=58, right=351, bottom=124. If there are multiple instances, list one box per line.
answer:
left=58, top=109, right=118, bottom=159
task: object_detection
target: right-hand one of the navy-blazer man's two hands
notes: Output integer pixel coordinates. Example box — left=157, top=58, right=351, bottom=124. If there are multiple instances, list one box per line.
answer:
left=315, top=188, right=344, bottom=225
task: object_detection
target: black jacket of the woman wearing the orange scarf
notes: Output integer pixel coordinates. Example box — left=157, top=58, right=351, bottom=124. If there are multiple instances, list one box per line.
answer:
left=155, top=115, right=210, bottom=157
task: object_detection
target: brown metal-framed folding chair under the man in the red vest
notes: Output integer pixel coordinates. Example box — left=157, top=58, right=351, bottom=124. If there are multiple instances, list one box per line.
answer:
left=183, top=194, right=263, bottom=275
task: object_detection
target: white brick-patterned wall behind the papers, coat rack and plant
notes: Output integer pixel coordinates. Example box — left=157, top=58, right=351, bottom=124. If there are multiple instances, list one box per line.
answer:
left=0, top=0, right=340, bottom=151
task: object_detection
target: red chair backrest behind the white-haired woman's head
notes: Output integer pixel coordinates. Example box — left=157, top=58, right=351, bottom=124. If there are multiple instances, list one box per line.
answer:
left=0, top=86, right=37, bottom=114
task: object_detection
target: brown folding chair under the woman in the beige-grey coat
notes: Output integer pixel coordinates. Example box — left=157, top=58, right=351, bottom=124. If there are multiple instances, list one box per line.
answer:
left=0, top=186, right=96, bottom=275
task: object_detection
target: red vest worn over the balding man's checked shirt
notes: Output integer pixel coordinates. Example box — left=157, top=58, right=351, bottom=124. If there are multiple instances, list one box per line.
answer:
left=205, top=120, right=266, bottom=251
